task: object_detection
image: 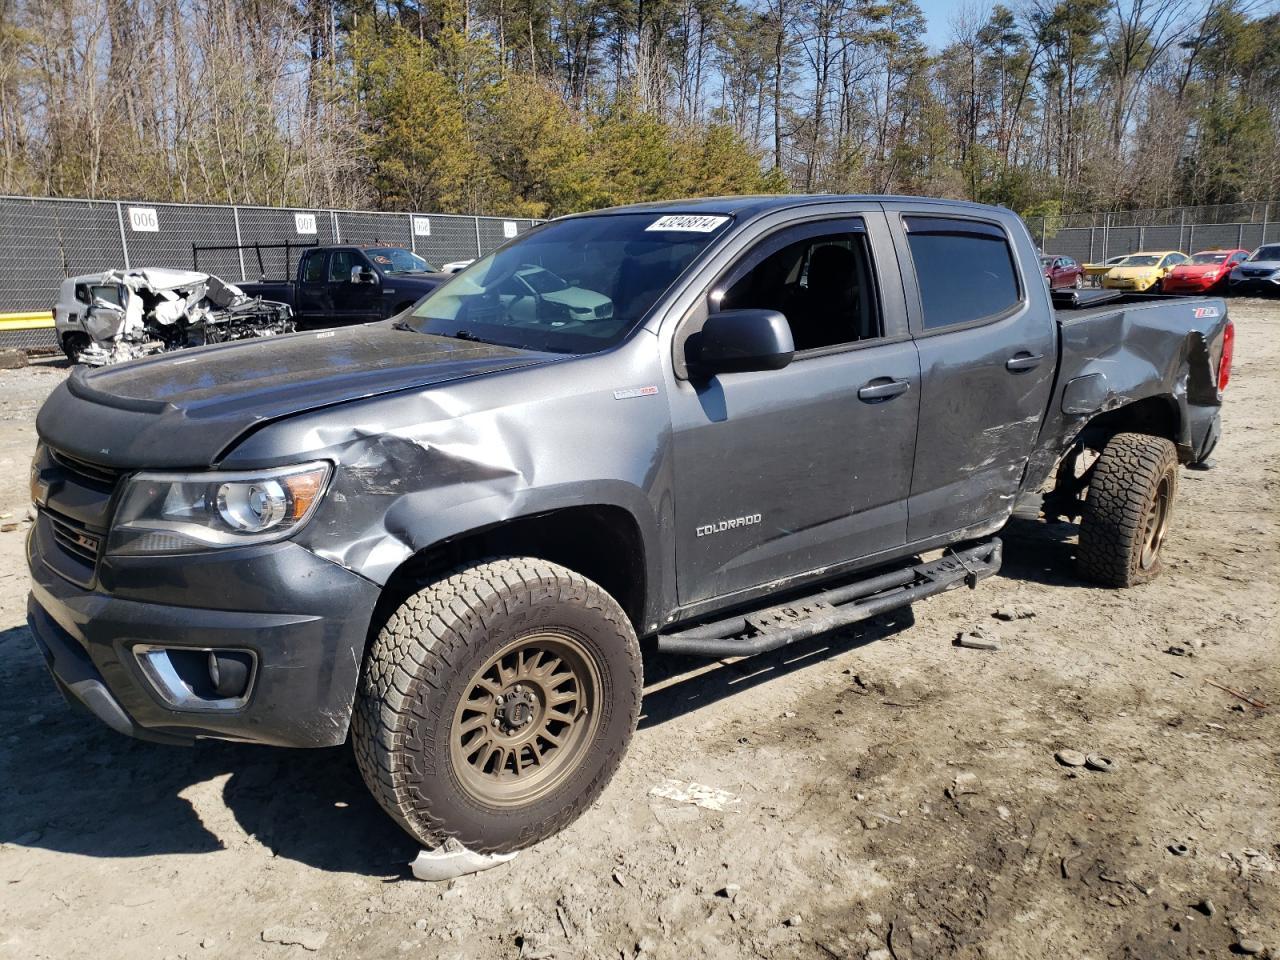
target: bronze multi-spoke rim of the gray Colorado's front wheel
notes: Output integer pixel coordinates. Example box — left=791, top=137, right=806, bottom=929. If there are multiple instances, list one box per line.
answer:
left=449, top=632, right=600, bottom=806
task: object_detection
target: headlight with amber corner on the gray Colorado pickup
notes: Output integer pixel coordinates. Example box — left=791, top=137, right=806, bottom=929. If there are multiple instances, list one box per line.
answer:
left=106, top=461, right=330, bottom=556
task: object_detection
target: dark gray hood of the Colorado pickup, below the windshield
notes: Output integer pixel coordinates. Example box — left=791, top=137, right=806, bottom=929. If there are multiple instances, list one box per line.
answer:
left=36, top=321, right=558, bottom=467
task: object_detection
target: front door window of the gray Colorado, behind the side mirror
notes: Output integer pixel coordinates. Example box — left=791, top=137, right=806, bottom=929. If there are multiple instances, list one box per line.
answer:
left=710, top=220, right=881, bottom=352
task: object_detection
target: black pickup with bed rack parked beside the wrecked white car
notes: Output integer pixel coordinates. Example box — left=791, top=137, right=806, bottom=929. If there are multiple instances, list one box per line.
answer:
left=237, top=244, right=453, bottom=326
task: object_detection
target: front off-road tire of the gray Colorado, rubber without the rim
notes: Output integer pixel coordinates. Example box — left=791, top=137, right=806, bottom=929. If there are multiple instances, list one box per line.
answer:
left=352, top=557, right=641, bottom=854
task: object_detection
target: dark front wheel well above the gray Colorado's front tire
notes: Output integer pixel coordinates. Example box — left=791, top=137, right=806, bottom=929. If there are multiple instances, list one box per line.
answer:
left=374, top=506, right=645, bottom=630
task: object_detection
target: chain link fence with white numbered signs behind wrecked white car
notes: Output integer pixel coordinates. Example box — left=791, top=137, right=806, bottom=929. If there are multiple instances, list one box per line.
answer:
left=0, top=196, right=539, bottom=314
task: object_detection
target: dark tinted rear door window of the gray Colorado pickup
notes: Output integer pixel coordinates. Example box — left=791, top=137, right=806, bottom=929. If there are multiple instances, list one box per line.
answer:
left=904, top=216, right=1021, bottom=330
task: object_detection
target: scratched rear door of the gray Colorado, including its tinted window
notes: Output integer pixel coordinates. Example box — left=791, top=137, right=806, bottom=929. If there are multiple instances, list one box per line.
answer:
left=886, top=204, right=1057, bottom=541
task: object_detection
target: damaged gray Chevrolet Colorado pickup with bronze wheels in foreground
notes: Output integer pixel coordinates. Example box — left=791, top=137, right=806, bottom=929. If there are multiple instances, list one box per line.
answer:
left=28, top=197, right=1233, bottom=852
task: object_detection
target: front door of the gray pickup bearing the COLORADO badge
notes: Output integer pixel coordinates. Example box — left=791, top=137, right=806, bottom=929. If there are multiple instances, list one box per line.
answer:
left=671, top=212, right=920, bottom=605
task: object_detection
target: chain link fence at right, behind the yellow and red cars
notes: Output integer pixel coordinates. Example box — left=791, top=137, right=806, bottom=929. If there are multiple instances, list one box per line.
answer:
left=1027, top=201, right=1280, bottom=264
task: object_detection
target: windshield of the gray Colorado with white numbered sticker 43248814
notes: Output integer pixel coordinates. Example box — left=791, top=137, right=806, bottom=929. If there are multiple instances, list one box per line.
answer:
left=402, top=212, right=730, bottom=353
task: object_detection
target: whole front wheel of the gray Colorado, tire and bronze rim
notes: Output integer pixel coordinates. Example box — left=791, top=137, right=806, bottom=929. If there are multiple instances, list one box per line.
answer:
left=352, top=557, right=641, bottom=854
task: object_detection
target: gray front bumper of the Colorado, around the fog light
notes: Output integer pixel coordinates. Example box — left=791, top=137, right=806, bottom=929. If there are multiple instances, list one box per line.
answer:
left=27, top=515, right=379, bottom=746
